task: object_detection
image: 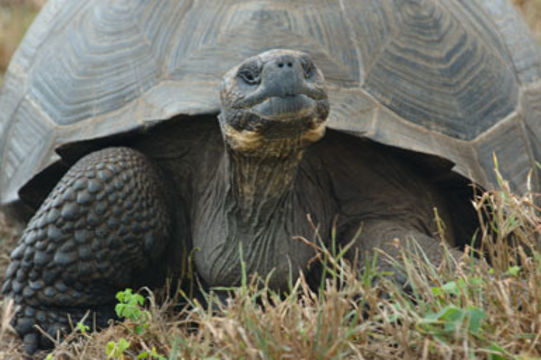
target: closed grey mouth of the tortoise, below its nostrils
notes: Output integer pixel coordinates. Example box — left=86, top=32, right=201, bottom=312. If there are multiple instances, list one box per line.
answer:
left=251, top=94, right=317, bottom=121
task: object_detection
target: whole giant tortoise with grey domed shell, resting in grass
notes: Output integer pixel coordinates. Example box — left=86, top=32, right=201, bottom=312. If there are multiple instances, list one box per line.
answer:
left=0, top=0, right=541, bottom=352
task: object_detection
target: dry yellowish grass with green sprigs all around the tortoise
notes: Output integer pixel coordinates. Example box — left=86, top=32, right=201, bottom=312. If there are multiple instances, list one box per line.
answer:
left=0, top=0, right=541, bottom=360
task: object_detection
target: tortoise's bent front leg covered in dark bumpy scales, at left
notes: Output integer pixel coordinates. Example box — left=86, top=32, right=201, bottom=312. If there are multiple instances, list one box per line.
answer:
left=2, top=148, right=170, bottom=353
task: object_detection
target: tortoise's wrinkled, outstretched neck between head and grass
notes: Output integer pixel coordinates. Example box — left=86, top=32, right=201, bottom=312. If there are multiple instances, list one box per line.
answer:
left=192, top=136, right=331, bottom=289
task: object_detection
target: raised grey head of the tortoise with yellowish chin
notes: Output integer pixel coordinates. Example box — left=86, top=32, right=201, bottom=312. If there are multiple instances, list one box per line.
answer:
left=219, top=49, right=329, bottom=156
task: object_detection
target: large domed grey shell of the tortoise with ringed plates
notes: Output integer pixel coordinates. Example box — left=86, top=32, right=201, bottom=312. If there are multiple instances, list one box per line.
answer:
left=0, top=0, right=541, bottom=211
